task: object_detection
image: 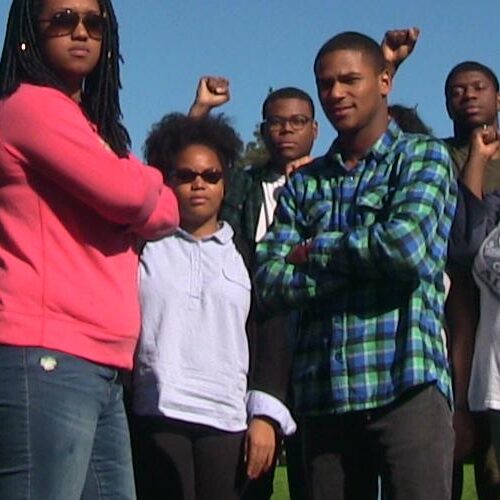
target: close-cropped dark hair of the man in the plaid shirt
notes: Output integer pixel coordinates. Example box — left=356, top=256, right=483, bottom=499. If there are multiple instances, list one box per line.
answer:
left=314, top=31, right=387, bottom=73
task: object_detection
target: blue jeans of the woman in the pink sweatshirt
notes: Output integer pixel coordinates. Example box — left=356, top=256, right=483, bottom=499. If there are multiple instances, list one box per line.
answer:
left=0, top=345, right=135, bottom=500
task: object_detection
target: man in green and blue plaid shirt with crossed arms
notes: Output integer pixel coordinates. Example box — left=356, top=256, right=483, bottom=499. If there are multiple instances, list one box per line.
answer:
left=257, top=32, right=456, bottom=500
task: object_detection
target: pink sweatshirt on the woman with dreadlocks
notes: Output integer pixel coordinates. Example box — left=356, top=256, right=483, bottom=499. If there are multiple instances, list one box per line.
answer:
left=0, top=84, right=179, bottom=368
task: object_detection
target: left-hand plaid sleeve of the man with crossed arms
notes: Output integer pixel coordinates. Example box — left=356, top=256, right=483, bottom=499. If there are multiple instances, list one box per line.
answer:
left=255, top=176, right=345, bottom=310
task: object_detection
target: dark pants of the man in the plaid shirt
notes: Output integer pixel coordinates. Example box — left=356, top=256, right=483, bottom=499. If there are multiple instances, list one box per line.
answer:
left=304, top=385, right=454, bottom=500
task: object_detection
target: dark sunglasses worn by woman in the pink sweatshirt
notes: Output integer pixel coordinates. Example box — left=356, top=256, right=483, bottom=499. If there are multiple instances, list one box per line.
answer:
left=38, top=9, right=105, bottom=40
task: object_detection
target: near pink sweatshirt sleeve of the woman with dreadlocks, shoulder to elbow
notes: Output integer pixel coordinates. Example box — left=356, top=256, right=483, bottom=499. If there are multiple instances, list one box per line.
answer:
left=1, top=87, right=172, bottom=225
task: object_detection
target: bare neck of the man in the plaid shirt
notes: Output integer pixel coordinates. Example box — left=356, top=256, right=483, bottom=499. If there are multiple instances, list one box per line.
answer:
left=338, top=108, right=389, bottom=168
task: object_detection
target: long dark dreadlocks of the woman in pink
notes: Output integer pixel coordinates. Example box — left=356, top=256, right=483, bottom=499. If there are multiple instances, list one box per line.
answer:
left=0, top=0, right=130, bottom=158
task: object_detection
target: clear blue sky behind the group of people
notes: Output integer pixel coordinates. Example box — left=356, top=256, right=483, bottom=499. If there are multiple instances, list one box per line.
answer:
left=0, top=0, right=500, bottom=155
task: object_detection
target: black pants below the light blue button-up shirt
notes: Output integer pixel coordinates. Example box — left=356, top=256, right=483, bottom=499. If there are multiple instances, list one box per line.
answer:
left=131, top=417, right=248, bottom=500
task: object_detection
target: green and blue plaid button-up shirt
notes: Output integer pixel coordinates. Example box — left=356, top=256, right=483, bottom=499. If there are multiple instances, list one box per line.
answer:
left=256, top=122, right=456, bottom=414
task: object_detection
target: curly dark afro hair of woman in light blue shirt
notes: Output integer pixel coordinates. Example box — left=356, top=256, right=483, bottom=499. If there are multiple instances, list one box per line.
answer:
left=144, top=113, right=243, bottom=179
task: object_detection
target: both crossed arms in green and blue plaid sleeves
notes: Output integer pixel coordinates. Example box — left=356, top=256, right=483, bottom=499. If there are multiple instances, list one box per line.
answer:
left=256, top=141, right=456, bottom=309
